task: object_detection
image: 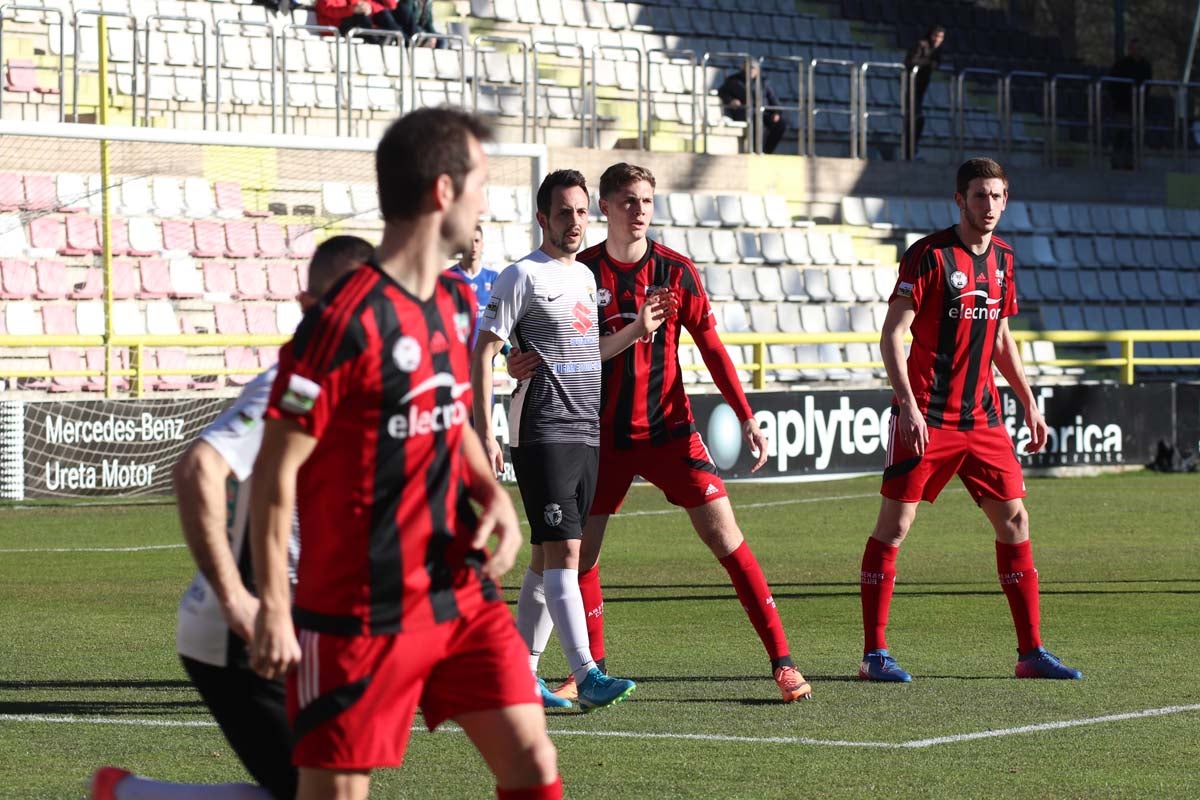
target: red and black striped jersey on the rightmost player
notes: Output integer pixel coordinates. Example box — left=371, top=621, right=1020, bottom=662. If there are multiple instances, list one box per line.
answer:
left=889, top=228, right=1016, bottom=431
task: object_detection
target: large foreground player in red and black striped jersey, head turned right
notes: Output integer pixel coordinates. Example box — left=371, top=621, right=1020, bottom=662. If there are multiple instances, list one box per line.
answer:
left=251, top=108, right=563, bottom=800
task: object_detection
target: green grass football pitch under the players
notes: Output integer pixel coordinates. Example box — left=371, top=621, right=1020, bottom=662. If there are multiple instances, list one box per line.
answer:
left=0, top=474, right=1200, bottom=800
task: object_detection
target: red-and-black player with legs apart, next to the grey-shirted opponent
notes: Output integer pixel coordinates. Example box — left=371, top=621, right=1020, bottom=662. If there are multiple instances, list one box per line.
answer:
left=578, top=163, right=812, bottom=702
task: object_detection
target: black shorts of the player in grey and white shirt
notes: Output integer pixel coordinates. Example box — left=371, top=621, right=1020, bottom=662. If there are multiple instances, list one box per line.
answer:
left=509, top=444, right=600, bottom=545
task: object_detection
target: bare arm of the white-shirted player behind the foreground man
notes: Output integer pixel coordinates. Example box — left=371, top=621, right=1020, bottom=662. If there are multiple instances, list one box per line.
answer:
left=172, top=440, right=242, bottom=604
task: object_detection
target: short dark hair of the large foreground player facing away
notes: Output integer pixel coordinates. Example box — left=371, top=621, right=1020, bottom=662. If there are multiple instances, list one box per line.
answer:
left=376, top=106, right=492, bottom=222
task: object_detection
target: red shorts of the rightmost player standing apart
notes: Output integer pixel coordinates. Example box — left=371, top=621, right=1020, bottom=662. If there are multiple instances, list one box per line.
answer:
left=880, top=416, right=1025, bottom=503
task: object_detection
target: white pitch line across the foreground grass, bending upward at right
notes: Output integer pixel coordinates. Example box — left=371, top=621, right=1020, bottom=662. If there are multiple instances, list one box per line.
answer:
left=0, top=704, right=1200, bottom=750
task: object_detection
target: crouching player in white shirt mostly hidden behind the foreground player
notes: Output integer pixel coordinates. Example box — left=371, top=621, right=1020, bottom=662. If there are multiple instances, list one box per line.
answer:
left=91, top=236, right=373, bottom=800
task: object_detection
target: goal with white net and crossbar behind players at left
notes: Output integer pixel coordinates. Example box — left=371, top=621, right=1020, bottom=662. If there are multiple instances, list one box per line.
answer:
left=0, top=121, right=546, bottom=499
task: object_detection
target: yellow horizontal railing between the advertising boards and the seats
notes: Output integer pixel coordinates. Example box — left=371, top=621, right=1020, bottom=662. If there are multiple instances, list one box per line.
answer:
left=0, top=330, right=1200, bottom=396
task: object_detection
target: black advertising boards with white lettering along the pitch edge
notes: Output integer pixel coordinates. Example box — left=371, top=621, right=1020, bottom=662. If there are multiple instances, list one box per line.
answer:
left=0, top=384, right=1180, bottom=500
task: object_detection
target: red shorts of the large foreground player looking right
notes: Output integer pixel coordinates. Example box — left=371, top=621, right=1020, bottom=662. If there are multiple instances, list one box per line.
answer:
left=287, top=602, right=539, bottom=770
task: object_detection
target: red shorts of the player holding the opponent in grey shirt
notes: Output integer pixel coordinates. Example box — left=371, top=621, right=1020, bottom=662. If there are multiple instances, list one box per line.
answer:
left=592, top=432, right=727, bottom=515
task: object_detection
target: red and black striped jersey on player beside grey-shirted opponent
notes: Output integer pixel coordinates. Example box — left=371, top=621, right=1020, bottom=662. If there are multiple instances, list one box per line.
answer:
left=576, top=240, right=716, bottom=449
